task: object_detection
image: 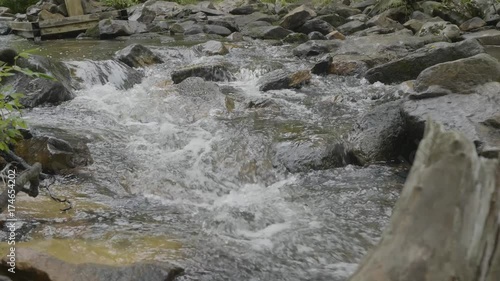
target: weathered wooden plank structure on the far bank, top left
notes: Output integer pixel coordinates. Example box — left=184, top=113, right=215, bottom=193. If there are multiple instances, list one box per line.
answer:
left=9, top=0, right=128, bottom=41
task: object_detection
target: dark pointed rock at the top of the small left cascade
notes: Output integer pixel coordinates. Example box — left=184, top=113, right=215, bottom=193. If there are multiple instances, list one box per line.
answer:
left=115, top=44, right=163, bottom=67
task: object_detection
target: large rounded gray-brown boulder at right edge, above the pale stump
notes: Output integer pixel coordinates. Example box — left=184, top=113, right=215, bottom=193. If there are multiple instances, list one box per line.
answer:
left=415, top=54, right=500, bottom=94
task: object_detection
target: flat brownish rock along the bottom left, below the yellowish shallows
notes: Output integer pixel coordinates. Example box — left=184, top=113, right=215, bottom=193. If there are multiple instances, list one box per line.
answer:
left=0, top=248, right=184, bottom=281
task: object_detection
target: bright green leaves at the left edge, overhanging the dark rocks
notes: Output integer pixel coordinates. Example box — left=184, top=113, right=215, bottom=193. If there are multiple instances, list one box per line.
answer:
left=0, top=50, right=50, bottom=151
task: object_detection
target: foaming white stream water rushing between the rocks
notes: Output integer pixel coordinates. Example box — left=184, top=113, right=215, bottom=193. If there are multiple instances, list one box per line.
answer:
left=0, top=36, right=406, bottom=281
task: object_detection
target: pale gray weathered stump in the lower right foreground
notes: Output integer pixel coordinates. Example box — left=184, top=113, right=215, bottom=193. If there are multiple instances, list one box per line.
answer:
left=348, top=122, right=500, bottom=281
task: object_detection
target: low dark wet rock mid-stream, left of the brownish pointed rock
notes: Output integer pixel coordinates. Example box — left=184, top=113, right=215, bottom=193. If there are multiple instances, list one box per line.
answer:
left=172, top=63, right=232, bottom=84
